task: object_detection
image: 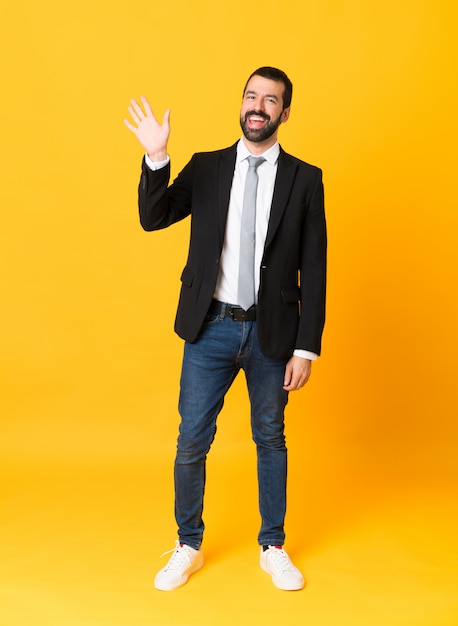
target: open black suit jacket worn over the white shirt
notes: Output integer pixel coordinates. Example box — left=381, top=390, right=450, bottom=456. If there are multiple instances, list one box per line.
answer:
left=139, top=144, right=326, bottom=358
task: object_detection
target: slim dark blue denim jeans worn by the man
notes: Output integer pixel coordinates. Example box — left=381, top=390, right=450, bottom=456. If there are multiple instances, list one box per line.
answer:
left=175, top=308, right=288, bottom=549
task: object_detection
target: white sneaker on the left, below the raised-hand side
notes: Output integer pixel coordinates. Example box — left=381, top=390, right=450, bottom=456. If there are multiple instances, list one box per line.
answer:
left=154, top=541, right=204, bottom=591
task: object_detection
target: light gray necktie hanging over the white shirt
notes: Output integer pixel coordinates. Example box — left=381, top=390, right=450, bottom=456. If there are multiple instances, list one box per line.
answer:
left=237, top=156, right=265, bottom=311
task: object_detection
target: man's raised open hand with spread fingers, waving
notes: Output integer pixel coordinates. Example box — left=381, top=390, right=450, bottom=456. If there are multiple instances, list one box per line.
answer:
left=124, top=96, right=170, bottom=161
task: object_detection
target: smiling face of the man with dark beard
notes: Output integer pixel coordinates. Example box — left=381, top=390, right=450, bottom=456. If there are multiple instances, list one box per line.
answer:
left=240, top=75, right=289, bottom=145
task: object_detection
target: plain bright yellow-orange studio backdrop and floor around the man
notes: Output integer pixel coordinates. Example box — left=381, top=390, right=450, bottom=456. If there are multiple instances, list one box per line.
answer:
left=0, top=0, right=458, bottom=626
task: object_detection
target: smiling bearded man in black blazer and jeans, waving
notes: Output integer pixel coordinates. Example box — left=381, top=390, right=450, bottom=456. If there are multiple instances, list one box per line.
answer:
left=125, top=67, right=326, bottom=590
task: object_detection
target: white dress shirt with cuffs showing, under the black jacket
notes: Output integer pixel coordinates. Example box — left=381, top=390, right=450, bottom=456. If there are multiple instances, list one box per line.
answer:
left=145, top=139, right=318, bottom=360
